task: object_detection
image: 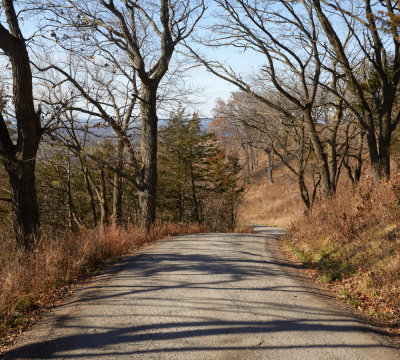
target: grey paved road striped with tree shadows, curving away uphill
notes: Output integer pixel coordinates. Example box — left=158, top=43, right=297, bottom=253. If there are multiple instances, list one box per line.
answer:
left=6, top=228, right=400, bottom=360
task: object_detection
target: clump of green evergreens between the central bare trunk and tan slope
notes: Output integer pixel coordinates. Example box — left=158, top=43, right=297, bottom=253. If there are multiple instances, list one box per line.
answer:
left=158, top=108, right=243, bottom=229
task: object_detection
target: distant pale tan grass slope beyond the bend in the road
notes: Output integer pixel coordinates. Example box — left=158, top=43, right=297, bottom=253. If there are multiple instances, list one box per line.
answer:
left=238, top=165, right=304, bottom=227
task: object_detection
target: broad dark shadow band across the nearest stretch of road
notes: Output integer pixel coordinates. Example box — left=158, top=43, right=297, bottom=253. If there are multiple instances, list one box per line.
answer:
left=5, top=318, right=392, bottom=359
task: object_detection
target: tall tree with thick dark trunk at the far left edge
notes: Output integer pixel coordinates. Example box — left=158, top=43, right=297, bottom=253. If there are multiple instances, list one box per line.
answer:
left=0, top=0, right=42, bottom=248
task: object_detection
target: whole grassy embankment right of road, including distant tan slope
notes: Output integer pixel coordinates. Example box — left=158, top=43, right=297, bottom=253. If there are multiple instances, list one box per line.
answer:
left=239, top=161, right=400, bottom=328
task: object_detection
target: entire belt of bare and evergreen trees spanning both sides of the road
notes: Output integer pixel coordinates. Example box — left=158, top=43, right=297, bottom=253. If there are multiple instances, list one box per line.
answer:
left=0, top=0, right=400, bottom=248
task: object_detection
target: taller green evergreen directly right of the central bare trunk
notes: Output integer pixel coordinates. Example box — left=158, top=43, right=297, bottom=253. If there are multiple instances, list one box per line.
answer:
left=158, top=109, right=217, bottom=224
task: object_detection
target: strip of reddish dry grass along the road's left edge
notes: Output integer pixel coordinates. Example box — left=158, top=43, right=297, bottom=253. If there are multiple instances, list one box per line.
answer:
left=0, top=224, right=204, bottom=348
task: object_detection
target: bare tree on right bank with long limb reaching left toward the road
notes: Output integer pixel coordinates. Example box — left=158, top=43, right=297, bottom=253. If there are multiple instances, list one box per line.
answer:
left=190, top=0, right=348, bottom=196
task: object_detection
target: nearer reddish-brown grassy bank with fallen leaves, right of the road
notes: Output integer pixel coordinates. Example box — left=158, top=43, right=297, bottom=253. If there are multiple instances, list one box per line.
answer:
left=287, top=175, right=400, bottom=325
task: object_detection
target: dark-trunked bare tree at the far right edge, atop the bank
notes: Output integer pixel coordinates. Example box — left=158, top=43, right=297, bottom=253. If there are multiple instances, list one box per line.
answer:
left=308, top=0, right=400, bottom=182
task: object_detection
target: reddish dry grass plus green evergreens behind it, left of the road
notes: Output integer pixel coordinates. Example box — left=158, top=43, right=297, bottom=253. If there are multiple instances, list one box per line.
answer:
left=0, top=109, right=245, bottom=346
